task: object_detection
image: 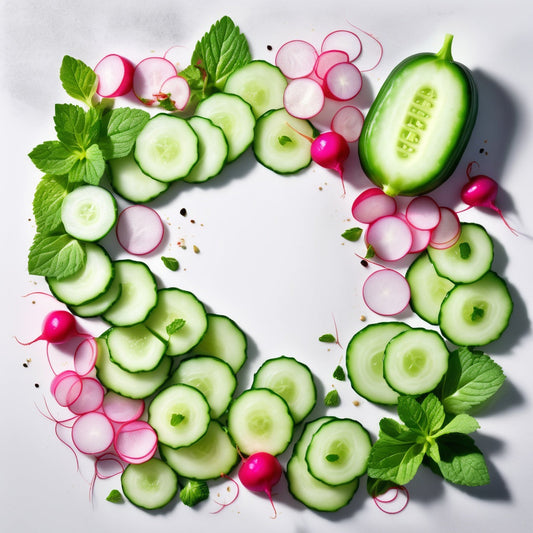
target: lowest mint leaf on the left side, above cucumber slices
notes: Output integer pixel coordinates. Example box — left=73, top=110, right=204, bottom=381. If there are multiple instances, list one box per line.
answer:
left=28, top=233, right=86, bottom=279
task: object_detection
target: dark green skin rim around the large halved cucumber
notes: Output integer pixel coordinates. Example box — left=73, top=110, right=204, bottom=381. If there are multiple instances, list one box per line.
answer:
left=358, top=39, right=478, bottom=196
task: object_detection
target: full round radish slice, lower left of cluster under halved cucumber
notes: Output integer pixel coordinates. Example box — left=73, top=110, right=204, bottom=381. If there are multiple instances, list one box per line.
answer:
left=366, top=215, right=413, bottom=261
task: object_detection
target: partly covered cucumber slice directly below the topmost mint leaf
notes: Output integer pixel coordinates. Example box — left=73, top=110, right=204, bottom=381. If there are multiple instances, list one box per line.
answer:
left=195, top=93, right=255, bottom=163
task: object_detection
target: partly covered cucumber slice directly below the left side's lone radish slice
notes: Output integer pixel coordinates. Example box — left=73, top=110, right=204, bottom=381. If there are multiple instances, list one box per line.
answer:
left=102, top=259, right=157, bottom=326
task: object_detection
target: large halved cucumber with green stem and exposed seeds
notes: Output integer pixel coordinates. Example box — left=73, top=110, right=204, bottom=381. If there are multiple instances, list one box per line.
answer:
left=359, top=34, right=478, bottom=196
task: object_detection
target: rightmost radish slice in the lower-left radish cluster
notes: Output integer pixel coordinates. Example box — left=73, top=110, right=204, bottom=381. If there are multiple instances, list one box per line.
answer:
left=114, top=420, right=157, bottom=464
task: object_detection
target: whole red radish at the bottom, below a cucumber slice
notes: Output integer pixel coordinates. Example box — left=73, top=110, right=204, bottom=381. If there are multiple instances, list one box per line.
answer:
left=239, top=452, right=282, bottom=515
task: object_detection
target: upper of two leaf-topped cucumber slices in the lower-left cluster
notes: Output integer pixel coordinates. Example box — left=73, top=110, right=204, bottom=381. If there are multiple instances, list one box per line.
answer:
left=146, top=287, right=207, bottom=355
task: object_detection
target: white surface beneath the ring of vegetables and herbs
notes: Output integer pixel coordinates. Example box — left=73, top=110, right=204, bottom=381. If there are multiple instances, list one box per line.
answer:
left=0, top=0, right=533, bottom=533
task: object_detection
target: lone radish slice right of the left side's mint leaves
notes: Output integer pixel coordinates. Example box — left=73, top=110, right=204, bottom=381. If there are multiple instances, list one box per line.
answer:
left=116, top=205, right=165, bottom=255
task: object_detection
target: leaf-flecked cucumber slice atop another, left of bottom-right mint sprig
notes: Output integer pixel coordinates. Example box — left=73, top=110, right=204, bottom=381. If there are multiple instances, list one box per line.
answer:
left=305, top=418, right=372, bottom=486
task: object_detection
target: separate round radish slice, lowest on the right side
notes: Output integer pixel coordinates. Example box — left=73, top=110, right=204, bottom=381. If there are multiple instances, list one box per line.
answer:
left=363, top=268, right=411, bottom=316
